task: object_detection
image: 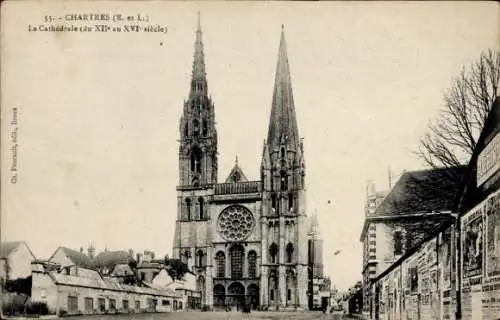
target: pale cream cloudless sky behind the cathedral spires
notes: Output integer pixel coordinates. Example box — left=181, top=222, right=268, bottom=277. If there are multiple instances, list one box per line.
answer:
left=1, top=1, right=499, bottom=288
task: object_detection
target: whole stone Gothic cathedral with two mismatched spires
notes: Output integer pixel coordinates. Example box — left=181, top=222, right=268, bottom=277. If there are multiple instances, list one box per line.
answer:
left=173, top=18, right=322, bottom=310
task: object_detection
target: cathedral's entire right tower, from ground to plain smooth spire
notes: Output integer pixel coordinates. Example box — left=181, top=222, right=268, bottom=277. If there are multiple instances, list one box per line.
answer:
left=261, top=26, right=307, bottom=308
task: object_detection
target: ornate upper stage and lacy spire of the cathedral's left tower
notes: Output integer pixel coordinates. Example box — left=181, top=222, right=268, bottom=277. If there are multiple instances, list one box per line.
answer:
left=179, top=14, right=217, bottom=188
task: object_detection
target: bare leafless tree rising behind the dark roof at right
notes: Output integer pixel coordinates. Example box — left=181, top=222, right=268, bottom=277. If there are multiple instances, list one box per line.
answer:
left=416, top=49, right=500, bottom=168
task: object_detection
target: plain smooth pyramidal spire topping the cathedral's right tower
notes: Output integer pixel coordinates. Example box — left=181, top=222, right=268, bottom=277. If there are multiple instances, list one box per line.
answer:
left=267, top=25, right=300, bottom=150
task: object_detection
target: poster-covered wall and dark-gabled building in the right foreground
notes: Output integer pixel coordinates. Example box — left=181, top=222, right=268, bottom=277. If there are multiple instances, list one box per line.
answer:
left=369, top=98, right=500, bottom=320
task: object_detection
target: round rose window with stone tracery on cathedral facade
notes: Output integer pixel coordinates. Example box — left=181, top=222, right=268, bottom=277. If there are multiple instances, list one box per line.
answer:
left=217, top=206, right=255, bottom=241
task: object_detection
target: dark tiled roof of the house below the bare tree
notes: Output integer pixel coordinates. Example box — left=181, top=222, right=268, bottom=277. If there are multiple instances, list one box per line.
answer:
left=375, top=166, right=466, bottom=216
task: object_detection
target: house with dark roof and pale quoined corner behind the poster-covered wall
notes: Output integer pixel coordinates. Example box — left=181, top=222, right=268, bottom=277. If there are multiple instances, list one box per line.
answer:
left=360, top=167, right=466, bottom=317
